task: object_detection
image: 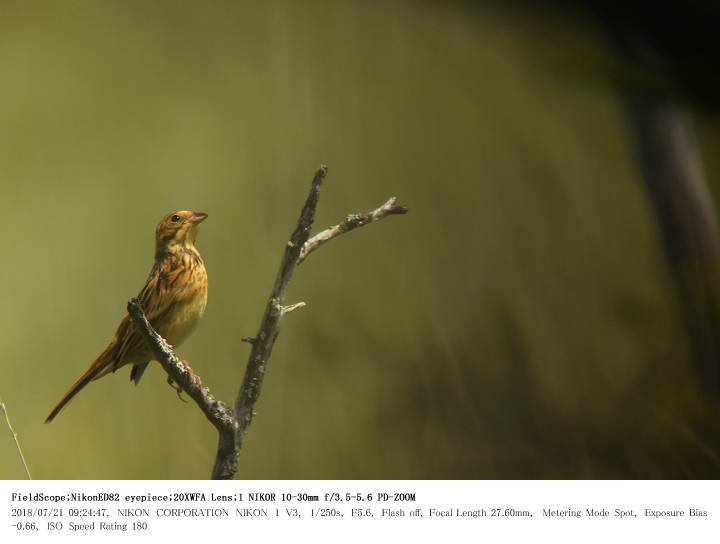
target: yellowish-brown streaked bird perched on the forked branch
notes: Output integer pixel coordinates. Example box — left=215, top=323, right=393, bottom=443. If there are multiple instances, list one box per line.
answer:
left=45, top=210, right=208, bottom=423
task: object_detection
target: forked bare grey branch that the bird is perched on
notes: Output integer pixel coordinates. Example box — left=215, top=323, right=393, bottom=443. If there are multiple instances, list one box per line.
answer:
left=128, top=166, right=407, bottom=479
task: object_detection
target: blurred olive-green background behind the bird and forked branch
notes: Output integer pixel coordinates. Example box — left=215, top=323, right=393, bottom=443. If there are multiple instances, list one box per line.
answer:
left=0, top=0, right=720, bottom=479
